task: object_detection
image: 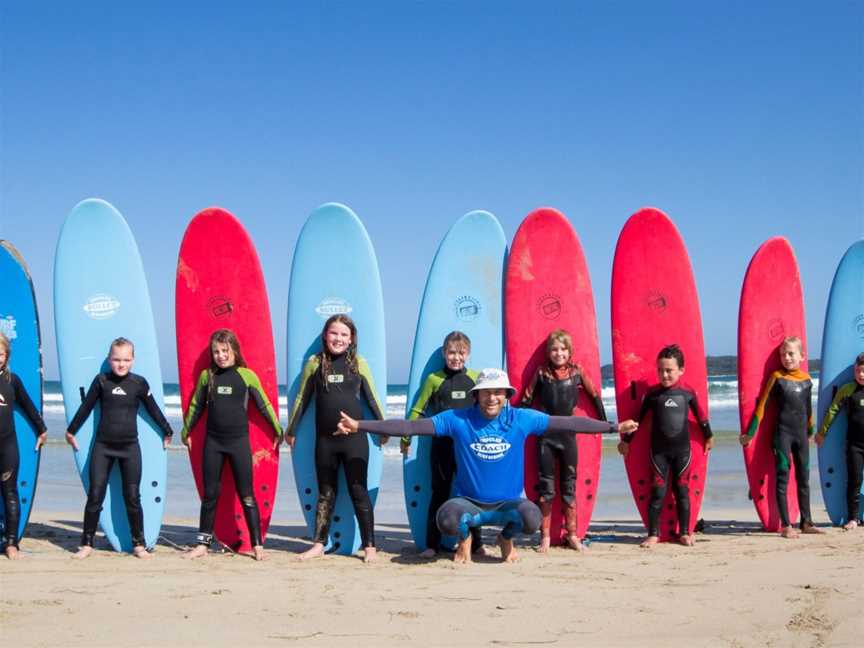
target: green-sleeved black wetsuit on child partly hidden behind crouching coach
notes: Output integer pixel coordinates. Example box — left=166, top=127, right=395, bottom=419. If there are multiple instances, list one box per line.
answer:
left=403, top=367, right=483, bottom=552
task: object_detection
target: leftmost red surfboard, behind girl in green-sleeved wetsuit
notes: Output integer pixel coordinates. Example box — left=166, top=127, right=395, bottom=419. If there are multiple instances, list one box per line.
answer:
left=175, top=207, right=279, bottom=551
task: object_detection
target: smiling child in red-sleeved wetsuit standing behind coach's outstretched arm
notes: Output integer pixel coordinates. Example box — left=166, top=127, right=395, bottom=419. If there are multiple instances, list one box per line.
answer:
left=520, top=329, right=606, bottom=553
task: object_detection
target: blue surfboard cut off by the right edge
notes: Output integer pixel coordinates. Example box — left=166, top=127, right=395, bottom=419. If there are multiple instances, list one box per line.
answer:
left=818, top=240, right=864, bottom=524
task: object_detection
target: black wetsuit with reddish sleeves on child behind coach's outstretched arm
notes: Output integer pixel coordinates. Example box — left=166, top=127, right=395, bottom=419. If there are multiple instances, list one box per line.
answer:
left=522, top=366, right=606, bottom=506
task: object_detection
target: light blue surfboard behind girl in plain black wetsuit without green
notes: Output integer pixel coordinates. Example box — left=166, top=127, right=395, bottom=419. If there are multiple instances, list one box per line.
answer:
left=54, top=199, right=167, bottom=551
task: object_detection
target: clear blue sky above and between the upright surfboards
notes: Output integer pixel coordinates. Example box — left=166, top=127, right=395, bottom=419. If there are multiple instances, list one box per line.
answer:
left=0, top=1, right=864, bottom=382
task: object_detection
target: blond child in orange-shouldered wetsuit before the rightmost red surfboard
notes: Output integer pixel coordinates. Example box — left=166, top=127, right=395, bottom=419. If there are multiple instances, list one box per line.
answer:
left=740, top=337, right=822, bottom=538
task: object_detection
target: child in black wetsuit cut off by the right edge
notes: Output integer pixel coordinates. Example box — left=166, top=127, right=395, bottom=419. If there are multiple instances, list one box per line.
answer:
left=816, top=353, right=864, bottom=531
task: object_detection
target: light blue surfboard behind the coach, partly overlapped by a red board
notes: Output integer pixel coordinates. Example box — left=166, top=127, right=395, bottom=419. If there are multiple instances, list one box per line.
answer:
left=402, top=211, right=507, bottom=550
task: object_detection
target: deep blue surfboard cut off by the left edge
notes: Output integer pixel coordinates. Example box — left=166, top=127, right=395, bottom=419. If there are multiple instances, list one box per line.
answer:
left=0, top=241, right=42, bottom=540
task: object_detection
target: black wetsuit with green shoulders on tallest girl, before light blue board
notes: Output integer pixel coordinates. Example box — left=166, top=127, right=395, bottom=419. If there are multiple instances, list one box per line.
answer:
left=288, top=354, right=384, bottom=547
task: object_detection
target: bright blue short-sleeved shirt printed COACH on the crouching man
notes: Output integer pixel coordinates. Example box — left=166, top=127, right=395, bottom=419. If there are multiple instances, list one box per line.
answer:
left=430, top=405, right=549, bottom=502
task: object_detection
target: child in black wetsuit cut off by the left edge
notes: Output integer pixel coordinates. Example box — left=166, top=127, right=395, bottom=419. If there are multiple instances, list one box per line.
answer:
left=0, top=333, right=48, bottom=560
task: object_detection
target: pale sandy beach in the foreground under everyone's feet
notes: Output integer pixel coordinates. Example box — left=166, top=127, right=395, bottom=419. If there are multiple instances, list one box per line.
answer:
left=0, top=511, right=864, bottom=648
